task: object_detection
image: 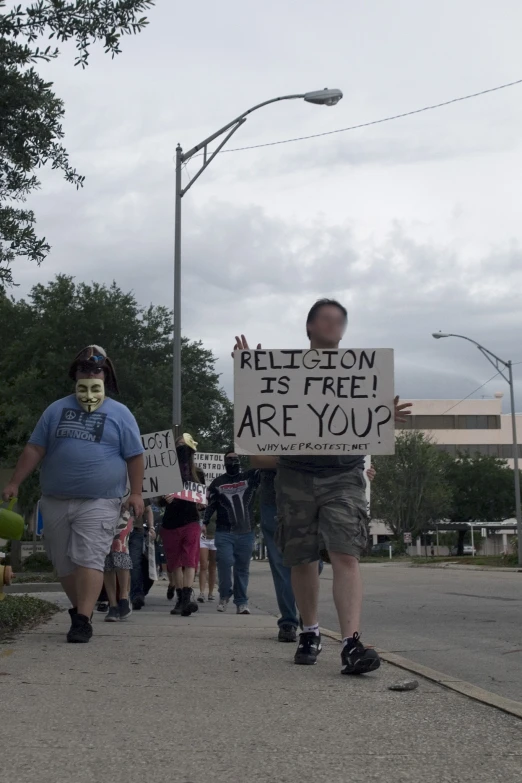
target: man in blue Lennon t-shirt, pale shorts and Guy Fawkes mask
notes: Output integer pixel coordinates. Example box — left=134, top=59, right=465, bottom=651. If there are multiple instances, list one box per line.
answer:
left=3, top=345, right=144, bottom=642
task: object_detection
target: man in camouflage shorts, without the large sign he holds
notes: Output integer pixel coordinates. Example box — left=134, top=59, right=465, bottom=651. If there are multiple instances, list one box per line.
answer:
left=235, top=299, right=410, bottom=674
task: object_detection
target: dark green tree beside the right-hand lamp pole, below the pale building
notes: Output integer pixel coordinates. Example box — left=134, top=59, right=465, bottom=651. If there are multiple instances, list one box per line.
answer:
left=440, top=454, right=515, bottom=555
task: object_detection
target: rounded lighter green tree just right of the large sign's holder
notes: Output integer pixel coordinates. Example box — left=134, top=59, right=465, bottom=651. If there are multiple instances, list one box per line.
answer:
left=371, top=430, right=452, bottom=547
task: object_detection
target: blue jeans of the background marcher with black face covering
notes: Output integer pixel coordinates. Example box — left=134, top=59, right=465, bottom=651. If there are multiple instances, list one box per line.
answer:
left=214, top=530, right=254, bottom=606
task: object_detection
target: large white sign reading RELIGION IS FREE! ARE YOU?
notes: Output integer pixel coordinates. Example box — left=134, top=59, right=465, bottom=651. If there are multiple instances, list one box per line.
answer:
left=234, top=348, right=395, bottom=456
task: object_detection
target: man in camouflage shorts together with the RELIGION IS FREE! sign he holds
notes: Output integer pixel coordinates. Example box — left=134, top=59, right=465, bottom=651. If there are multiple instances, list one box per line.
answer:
left=234, top=299, right=409, bottom=674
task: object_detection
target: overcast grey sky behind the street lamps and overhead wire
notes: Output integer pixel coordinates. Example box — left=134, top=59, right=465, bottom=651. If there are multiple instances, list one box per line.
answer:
left=11, top=0, right=522, bottom=407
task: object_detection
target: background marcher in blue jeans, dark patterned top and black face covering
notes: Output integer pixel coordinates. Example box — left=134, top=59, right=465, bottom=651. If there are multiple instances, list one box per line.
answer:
left=203, top=451, right=259, bottom=614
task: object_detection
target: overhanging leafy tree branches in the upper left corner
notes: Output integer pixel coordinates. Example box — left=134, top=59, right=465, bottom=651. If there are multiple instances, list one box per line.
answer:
left=0, top=0, right=154, bottom=288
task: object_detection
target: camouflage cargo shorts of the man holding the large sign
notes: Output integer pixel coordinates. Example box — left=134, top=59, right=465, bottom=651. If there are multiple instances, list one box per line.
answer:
left=275, top=468, right=368, bottom=566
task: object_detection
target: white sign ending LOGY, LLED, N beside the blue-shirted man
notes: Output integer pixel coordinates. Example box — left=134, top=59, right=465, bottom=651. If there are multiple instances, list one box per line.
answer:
left=141, top=430, right=183, bottom=498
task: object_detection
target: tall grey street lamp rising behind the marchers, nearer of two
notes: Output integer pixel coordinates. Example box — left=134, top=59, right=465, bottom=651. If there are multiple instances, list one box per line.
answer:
left=172, top=89, right=343, bottom=438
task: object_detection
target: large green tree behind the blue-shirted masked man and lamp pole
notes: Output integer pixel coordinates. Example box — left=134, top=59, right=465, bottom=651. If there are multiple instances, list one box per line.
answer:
left=0, top=275, right=233, bottom=508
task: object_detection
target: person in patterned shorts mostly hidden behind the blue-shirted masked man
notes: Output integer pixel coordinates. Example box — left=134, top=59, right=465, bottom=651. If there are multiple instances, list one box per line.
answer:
left=103, top=509, right=134, bottom=623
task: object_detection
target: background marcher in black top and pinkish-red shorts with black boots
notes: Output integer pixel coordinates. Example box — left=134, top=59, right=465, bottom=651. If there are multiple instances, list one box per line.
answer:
left=161, top=433, right=205, bottom=617
